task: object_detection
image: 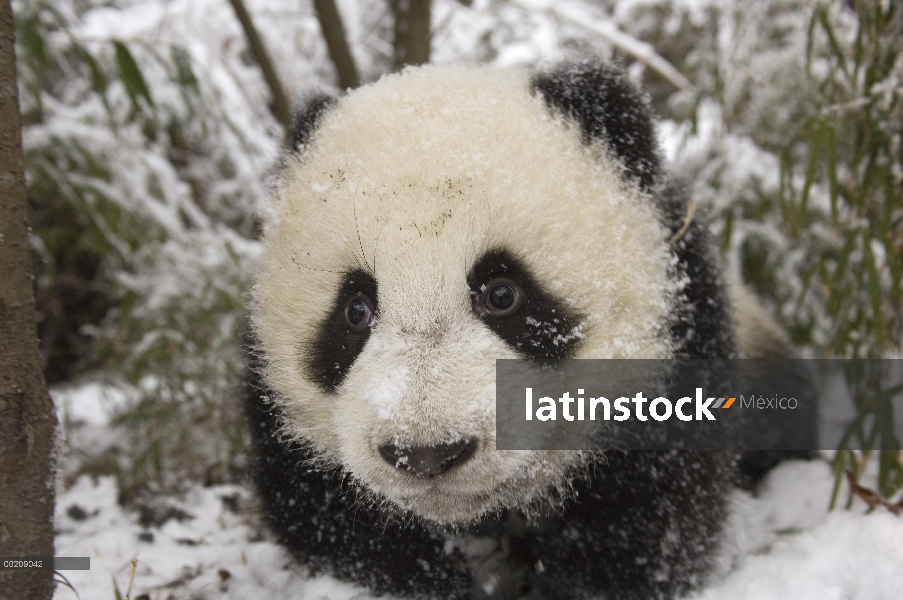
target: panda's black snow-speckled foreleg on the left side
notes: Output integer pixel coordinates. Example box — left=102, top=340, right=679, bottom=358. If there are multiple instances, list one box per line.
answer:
left=245, top=368, right=470, bottom=600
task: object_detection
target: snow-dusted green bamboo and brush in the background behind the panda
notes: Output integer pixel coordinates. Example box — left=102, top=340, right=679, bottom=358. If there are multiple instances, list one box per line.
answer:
left=13, top=0, right=903, bottom=497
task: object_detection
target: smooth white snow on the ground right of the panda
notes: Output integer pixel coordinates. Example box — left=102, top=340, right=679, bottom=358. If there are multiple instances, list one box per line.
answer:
left=708, top=461, right=903, bottom=600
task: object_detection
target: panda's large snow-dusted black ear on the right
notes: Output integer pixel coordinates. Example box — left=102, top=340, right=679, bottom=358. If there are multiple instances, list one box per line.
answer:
left=532, top=62, right=662, bottom=191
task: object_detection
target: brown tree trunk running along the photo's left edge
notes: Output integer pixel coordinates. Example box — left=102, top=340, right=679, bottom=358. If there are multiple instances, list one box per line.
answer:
left=0, top=0, right=56, bottom=600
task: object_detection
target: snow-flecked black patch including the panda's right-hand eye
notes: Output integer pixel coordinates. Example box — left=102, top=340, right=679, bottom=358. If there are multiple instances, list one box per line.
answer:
left=467, top=250, right=582, bottom=359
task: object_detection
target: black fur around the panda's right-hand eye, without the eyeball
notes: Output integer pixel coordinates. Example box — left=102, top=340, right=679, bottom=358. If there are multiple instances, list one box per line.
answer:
left=467, top=250, right=581, bottom=359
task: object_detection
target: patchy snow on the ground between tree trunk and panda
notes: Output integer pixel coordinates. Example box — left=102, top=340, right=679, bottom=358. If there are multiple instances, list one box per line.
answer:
left=54, top=476, right=365, bottom=600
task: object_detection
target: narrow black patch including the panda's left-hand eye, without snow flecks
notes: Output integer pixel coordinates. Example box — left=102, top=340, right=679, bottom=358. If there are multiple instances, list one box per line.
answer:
left=302, top=270, right=377, bottom=392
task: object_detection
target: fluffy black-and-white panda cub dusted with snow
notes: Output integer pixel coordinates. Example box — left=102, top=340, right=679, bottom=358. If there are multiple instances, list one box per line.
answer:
left=248, top=63, right=768, bottom=600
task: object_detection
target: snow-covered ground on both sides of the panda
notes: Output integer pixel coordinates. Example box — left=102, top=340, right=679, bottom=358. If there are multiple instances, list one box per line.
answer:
left=54, top=384, right=903, bottom=600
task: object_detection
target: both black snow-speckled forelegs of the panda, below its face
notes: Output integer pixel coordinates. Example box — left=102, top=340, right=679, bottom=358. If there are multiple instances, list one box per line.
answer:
left=246, top=368, right=731, bottom=600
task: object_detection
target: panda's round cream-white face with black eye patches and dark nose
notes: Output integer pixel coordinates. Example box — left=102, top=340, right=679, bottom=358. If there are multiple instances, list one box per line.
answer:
left=253, top=67, right=679, bottom=524
